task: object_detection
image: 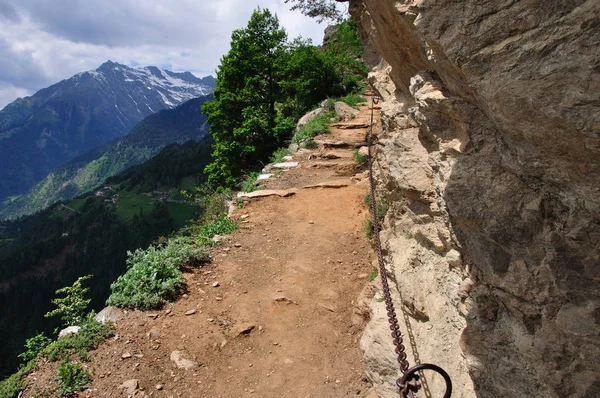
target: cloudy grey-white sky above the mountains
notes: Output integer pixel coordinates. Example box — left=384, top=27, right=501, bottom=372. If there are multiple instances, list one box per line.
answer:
left=0, top=0, right=342, bottom=109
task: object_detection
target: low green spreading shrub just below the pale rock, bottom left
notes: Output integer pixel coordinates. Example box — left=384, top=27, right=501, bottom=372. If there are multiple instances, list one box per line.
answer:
left=40, top=315, right=114, bottom=361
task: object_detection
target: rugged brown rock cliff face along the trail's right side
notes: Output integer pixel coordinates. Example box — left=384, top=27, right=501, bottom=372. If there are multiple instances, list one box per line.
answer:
left=350, top=0, right=600, bottom=397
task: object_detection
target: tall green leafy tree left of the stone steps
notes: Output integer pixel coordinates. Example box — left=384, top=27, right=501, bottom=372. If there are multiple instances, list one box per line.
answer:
left=202, top=8, right=287, bottom=186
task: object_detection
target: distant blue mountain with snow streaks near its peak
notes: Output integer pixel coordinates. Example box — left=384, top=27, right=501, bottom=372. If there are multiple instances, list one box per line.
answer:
left=0, top=61, right=215, bottom=199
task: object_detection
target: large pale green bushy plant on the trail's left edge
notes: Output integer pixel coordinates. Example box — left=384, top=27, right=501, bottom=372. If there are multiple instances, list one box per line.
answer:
left=106, top=237, right=208, bottom=310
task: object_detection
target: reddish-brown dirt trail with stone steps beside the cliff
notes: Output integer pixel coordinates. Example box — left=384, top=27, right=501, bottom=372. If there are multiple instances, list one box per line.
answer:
left=24, top=96, right=382, bottom=398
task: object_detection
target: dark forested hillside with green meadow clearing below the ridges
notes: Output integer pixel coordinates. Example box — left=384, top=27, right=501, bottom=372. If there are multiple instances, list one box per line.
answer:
left=0, top=140, right=211, bottom=375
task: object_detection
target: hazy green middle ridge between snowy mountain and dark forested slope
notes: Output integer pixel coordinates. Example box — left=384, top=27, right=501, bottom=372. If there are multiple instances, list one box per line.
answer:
left=0, top=95, right=212, bottom=219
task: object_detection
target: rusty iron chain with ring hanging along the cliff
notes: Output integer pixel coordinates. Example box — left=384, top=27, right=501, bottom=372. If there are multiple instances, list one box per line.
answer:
left=367, top=89, right=452, bottom=398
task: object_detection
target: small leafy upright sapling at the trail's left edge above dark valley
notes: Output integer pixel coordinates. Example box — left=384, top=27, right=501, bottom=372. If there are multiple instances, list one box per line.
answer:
left=44, top=275, right=92, bottom=326
